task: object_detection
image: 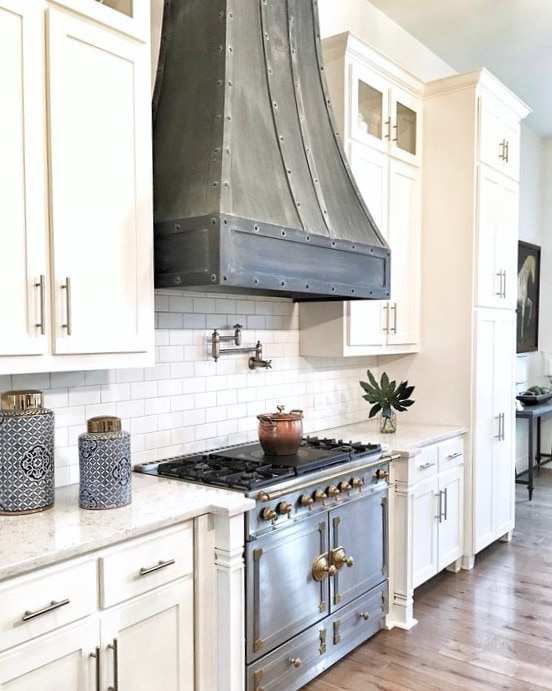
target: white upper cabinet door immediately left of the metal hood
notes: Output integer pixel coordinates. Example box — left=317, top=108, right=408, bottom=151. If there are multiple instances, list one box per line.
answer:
left=48, top=9, right=152, bottom=353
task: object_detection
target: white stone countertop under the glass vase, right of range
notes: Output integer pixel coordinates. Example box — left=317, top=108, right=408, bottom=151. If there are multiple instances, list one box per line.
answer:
left=312, top=415, right=467, bottom=455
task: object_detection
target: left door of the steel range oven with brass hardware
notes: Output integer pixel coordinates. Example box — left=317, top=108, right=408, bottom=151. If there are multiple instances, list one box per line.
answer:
left=245, top=512, right=329, bottom=663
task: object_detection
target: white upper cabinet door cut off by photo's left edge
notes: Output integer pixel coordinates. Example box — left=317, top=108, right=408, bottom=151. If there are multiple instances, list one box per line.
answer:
left=0, top=0, right=47, bottom=356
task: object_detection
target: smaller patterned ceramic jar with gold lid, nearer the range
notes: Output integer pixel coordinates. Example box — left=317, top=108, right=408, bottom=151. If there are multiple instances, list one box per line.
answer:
left=79, top=415, right=132, bottom=509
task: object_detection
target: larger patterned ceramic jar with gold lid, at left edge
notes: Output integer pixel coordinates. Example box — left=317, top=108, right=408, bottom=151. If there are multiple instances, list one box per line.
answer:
left=0, top=390, right=54, bottom=514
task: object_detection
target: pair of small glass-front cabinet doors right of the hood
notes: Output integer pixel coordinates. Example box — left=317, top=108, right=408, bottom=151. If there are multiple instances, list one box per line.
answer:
left=349, top=65, right=421, bottom=164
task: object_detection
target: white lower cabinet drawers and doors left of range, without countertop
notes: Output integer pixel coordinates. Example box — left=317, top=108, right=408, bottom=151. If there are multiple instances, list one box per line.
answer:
left=0, top=522, right=196, bottom=691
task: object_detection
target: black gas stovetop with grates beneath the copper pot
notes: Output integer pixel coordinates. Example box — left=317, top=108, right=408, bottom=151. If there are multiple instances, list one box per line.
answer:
left=138, top=437, right=382, bottom=491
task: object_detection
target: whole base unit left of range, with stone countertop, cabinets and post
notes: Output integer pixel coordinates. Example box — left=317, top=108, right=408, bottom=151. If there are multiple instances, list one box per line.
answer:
left=0, top=473, right=253, bottom=691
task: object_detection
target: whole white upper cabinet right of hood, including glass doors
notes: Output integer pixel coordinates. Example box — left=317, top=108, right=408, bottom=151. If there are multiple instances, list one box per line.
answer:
left=300, top=33, right=422, bottom=356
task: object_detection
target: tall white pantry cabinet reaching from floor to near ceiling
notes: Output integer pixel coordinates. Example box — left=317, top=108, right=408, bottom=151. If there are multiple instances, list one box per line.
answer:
left=416, top=69, right=528, bottom=568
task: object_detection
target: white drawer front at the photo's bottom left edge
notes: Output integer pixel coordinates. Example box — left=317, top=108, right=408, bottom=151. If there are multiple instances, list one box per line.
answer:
left=0, top=559, right=98, bottom=650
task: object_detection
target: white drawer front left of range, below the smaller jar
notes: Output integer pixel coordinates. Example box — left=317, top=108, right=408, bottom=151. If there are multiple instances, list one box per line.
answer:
left=99, top=521, right=194, bottom=607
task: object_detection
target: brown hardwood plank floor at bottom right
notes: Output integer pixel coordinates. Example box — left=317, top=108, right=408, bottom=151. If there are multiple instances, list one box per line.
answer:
left=303, top=466, right=552, bottom=691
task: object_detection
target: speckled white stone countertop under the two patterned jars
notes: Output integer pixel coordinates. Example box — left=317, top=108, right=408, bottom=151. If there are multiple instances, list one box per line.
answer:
left=0, top=473, right=254, bottom=580
